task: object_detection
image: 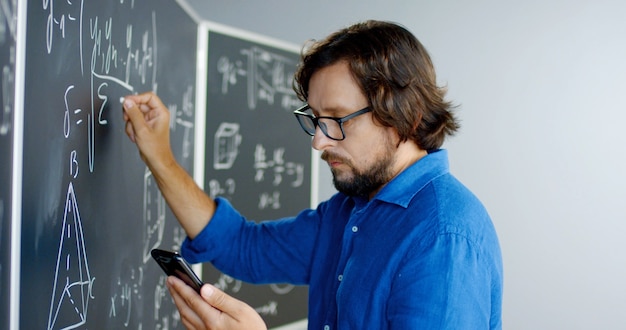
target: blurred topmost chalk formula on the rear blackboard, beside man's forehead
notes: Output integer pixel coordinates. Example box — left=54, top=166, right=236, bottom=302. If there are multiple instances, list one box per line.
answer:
left=217, top=46, right=301, bottom=110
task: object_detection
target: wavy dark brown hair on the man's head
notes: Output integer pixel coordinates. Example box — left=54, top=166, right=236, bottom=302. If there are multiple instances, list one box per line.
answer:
left=294, top=21, right=459, bottom=150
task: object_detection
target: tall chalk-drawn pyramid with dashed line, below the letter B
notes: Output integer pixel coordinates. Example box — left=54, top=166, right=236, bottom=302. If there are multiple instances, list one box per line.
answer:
left=48, top=182, right=95, bottom=330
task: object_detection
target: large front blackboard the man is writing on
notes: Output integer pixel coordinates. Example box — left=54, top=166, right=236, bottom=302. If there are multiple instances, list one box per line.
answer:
left=19, top=0, right=198, bottom=329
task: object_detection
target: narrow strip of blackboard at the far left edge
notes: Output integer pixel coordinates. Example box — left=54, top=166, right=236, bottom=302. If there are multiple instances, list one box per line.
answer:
left=0, top=0, right=18, bottom=329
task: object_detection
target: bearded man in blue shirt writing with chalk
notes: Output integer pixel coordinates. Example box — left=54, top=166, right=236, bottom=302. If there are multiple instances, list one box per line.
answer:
left=124, top=21, right=502, bottom=329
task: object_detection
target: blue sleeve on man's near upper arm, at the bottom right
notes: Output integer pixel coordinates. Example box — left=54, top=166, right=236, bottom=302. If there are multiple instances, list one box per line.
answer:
left=388, top=229, right=494, bottom=329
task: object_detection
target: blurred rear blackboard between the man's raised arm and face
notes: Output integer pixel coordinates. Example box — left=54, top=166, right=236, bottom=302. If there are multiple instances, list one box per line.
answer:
left=200, top=25, right=312, bottom=327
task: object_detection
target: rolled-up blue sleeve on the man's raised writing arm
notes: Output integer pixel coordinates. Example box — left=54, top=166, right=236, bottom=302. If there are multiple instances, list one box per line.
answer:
left=181, top=198, right=319, bottom=284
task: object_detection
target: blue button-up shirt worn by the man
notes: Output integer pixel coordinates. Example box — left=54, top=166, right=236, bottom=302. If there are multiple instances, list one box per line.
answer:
left=182, top=150, right=502, bottom=329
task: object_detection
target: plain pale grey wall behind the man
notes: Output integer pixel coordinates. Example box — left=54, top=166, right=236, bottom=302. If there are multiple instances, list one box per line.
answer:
left=183, top=0, right=626, bottom=329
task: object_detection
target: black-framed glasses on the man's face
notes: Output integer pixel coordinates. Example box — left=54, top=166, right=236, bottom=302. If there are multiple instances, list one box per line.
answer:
left=293, top=104, right=372, bottom=141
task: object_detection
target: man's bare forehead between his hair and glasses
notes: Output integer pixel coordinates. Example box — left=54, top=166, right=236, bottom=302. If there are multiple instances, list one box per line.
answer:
left=307, top=61, right=368, bottom=116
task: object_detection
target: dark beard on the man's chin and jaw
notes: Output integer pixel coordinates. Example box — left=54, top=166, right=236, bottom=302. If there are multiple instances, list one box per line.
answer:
left=322, top=139, right=395, bottom=197
